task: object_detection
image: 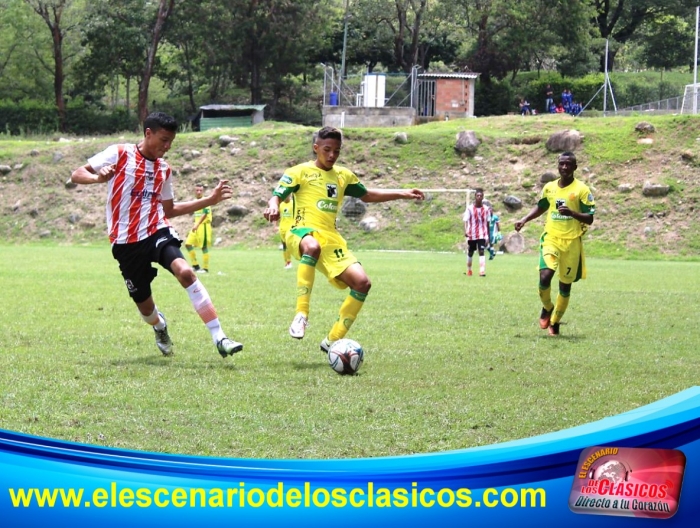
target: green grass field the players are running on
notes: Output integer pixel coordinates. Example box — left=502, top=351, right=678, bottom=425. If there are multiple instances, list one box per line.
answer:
left=0, top=245, right=700, bottom=458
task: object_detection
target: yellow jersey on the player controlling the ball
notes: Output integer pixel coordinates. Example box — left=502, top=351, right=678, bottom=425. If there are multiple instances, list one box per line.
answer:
left=273, top=161, right=367, bottom=231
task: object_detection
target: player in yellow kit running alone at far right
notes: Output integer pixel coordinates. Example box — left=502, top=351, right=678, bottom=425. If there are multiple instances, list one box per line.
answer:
left=515, top=152, right=595, bottom=335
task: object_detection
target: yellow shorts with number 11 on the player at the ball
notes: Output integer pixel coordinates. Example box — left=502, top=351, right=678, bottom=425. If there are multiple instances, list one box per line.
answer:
left=286, top=227, right=357, bottom=290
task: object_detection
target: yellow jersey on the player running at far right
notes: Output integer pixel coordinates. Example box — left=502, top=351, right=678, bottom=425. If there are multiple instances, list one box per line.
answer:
left=537, top=178, right=595, bottom=239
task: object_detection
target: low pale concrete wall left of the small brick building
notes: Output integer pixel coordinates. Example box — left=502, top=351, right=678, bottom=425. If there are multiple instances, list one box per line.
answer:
left=321, top=106, right=416, bottom=128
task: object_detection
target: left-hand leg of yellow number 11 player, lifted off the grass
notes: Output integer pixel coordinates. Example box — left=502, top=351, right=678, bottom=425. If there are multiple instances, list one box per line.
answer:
left=287, top=229, right=321, bottom=339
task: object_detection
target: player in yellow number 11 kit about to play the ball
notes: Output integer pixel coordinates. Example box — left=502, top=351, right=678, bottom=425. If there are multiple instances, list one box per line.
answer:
left=264, top=127, right=425, bottom=352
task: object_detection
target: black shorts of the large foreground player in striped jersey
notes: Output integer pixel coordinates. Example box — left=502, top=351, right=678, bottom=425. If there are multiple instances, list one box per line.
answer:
left=112, top=227, right=184, bottom=303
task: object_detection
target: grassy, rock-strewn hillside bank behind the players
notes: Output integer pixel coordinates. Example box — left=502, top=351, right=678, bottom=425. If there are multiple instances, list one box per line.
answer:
left=0, top=115, right=700, bottom=258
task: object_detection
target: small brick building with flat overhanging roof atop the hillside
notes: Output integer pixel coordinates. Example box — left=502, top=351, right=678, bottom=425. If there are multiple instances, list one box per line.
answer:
left=417, top=72, right=480, bottom=122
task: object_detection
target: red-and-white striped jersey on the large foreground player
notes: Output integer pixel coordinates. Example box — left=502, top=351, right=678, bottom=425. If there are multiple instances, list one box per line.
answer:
left=88, top=144, right=173, bottom=244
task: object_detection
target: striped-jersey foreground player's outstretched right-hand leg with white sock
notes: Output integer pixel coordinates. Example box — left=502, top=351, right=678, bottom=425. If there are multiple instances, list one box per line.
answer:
left=158, top=239, right=243, bottom=357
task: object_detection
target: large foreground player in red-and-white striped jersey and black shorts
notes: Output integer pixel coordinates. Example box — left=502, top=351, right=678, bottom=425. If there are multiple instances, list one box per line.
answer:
left=71, top=112, right=243, bottom=357
